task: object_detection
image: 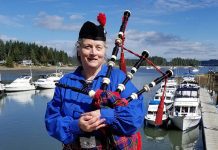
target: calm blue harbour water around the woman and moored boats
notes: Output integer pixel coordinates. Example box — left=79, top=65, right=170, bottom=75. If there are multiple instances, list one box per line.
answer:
left=0, top=68, right=213, bottom=150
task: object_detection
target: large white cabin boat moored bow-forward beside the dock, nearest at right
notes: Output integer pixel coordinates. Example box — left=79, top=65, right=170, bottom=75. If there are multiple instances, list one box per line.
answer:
left=169, top=87, right=201, bottom=130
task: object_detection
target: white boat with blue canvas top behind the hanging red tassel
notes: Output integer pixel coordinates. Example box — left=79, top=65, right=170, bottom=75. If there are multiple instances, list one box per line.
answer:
left=145, top=100, right=168, bottom=126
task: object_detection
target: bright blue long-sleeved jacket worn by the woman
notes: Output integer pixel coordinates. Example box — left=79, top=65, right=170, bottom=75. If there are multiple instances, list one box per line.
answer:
left=45, top=65, right=145, bottom=144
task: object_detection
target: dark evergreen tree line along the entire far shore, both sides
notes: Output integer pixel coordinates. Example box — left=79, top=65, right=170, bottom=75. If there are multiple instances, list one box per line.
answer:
left=0, top=39, right=200, bottom=67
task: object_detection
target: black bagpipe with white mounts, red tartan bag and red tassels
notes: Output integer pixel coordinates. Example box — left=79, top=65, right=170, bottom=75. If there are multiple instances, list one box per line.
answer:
left=56, top=10, right=173, bottom=149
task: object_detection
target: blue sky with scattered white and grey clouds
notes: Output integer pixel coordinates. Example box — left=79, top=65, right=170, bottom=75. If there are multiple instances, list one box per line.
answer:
left=0, top=0, right=218, bottom=60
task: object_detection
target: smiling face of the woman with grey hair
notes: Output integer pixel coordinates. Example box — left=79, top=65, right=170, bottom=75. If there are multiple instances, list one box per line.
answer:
left=77, top=39, right=106, bottom=70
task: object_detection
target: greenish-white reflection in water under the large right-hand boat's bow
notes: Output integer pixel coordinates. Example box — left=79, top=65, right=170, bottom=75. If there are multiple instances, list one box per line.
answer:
left=168, top=126, right=199, bottom=150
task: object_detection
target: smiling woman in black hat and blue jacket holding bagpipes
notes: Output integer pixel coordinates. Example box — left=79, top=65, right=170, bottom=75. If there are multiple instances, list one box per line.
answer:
left=45, top=17, right=145, bottom=150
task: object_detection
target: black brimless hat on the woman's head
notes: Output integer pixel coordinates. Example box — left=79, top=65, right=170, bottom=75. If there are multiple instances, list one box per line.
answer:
left=79, top=12, right=106, bottom=41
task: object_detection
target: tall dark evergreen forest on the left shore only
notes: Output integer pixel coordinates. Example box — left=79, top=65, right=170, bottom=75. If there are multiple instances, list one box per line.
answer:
left=0, top=39, right=71, bottom=67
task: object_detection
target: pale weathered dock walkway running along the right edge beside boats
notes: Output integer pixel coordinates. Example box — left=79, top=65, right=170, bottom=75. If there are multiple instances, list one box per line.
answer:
left=200, top=88, right=218, bottom=150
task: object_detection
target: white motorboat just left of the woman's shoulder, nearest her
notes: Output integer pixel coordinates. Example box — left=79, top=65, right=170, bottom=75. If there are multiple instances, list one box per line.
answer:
left=34, top=72, right=63, bottom=89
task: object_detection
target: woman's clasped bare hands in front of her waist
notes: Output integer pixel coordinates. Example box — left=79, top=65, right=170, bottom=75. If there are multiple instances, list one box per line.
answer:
left=79, top=109, right=106, bottom=132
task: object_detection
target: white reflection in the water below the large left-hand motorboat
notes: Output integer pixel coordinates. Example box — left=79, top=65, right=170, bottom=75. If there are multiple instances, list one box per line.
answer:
left=6, top=90, right=35, bottom=105
